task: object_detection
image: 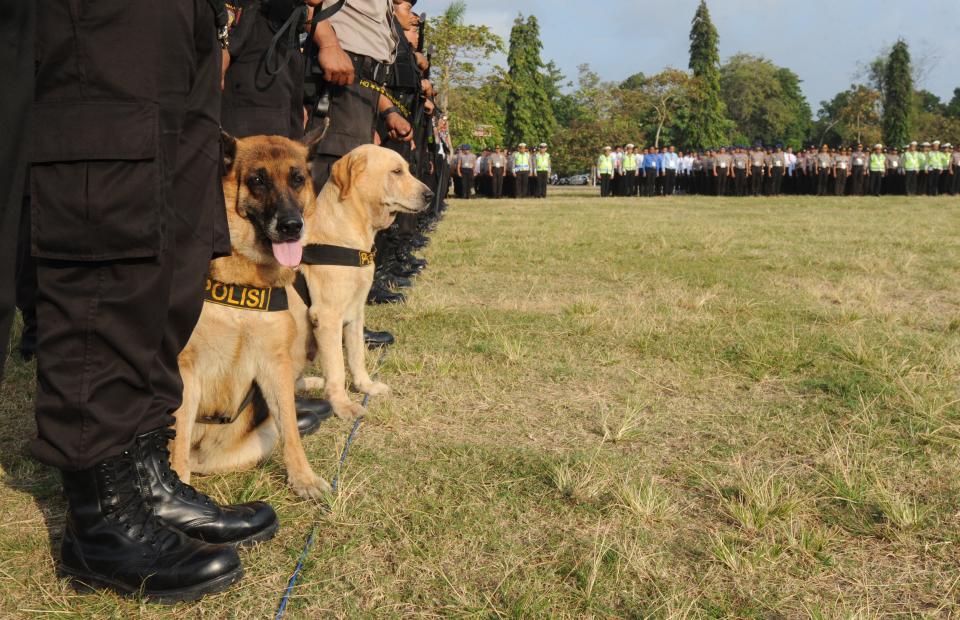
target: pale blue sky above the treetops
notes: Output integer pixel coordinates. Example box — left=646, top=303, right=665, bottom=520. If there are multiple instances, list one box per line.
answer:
left=416, top=0, right=960, bottom=112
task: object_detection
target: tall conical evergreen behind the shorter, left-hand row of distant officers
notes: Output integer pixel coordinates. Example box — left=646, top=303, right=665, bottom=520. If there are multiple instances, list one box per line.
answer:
left=504, top=15, right=556, bottom=144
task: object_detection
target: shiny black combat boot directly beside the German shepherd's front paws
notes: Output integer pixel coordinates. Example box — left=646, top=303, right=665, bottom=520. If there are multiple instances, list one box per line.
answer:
left=134, top=428, right=280, bottom=545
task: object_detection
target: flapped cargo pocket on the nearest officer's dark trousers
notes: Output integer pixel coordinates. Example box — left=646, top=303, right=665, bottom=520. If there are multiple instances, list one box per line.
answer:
left=30, top=101, right=164, bottom=261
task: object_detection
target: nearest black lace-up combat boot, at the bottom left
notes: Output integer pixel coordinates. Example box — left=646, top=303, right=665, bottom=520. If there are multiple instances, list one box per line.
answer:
left=59, top=452, right=243, bottom=603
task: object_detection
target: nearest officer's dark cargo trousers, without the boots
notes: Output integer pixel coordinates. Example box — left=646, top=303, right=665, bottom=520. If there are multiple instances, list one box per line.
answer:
left=31, top=0, right=229, bottom=469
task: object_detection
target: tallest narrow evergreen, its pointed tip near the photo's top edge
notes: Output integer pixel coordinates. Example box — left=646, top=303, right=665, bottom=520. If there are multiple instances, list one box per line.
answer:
left=685, top=0, right=730, bottom=148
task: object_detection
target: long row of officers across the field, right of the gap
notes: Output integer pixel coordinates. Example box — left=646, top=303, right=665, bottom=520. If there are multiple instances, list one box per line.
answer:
left=596, top=141, right=960, bottom=197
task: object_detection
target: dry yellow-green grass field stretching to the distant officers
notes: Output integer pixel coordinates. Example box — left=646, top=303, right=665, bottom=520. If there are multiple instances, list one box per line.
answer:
left=0, top=190, right=960, bottom=619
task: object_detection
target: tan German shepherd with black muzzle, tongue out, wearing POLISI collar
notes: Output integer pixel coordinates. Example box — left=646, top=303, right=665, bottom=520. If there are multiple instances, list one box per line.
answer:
left=171, top=136, right=330, bottom=497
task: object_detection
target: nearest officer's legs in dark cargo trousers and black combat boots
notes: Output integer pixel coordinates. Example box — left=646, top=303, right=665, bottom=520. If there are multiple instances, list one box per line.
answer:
left=24, top=0, right=277, bottom=601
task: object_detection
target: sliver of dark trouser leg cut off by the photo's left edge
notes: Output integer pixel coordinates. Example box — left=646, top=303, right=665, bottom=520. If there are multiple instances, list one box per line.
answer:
left=0, top=0, right=35, bottom=382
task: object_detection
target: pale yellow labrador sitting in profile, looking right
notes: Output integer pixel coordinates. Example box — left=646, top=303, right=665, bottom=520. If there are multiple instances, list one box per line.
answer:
left=298, top=145, right=433, bottom=420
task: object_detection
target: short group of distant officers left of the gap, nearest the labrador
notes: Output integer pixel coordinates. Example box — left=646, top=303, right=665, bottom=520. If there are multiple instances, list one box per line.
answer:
left=450, top=142, right=553, bottom=200
